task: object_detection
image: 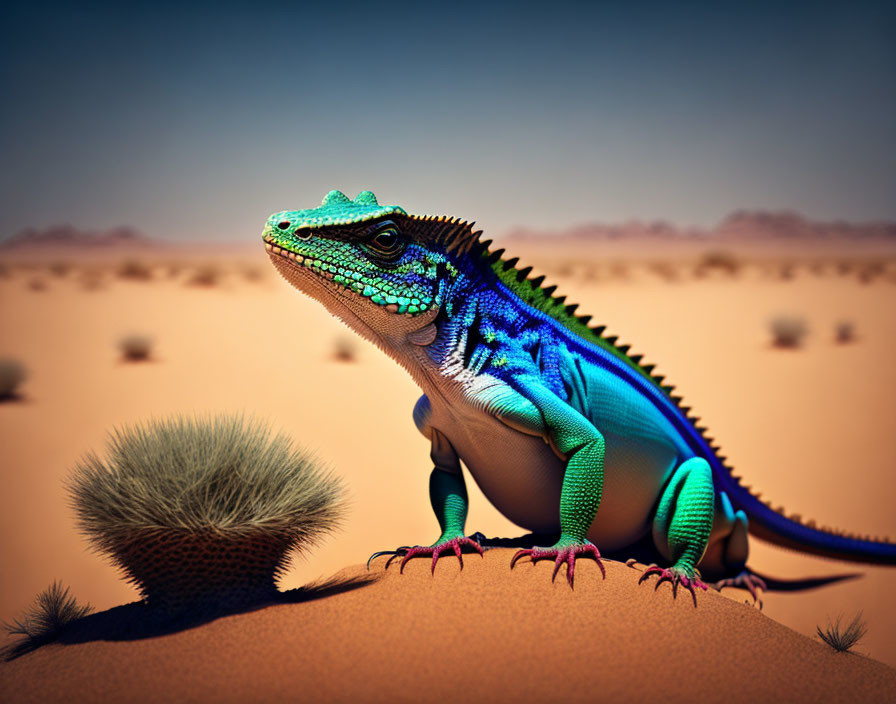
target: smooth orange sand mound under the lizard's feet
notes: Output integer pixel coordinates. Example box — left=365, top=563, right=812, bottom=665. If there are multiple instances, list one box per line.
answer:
left=0, top=549, right=896, bottom=704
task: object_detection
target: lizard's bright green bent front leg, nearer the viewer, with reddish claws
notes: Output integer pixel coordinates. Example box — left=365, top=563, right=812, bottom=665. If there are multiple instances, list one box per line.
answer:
left=510, top=384, right=606, bottom=587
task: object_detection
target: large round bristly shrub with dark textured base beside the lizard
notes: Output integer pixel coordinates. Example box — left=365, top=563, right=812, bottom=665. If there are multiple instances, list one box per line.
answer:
left=68, top=416, right=344, bottom=612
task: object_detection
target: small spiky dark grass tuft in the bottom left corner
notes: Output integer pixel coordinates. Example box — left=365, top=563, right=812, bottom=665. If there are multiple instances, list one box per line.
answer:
left=3, top=582, right=93, bottom=659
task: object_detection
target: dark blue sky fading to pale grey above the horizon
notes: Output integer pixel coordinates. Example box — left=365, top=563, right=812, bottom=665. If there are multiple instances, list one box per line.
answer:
left=0, top=0, right=896, bottom=242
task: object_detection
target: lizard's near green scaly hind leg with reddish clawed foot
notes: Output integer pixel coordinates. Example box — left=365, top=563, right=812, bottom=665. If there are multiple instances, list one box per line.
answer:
left=638, top=457, right=715, bottom=606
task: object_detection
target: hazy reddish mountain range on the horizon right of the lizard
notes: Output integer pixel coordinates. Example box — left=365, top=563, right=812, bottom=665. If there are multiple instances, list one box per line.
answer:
left=508, top=210, right=896, bottom=242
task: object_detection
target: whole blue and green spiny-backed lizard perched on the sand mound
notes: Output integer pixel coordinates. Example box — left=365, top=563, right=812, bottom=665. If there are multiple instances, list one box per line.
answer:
left=262, top=190, right=896, bottom=605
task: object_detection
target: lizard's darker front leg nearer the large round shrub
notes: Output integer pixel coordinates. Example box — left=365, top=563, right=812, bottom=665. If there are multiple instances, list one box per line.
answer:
left=367, top=428, right=483, bottom=573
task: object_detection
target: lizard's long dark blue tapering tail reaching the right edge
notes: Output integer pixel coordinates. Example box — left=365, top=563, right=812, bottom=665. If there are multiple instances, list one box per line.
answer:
left=714, top=465, right=896, bottom=565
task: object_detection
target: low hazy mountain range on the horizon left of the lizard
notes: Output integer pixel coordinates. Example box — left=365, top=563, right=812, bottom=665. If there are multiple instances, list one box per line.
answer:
left=0, top=225, right=160, bottom=251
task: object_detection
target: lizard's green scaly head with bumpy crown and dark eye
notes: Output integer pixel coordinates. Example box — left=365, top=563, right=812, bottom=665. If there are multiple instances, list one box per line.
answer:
left=262, top=191, right=478, bottom=348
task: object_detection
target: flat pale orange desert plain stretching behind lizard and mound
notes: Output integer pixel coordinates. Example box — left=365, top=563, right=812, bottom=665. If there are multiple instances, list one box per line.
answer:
left=0, top=245, right=896, bottom=672
